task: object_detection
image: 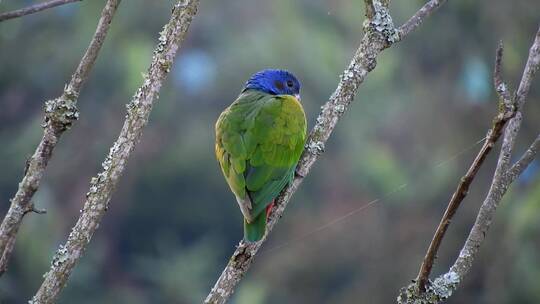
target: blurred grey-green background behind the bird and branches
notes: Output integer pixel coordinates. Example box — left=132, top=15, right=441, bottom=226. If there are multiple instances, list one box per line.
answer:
left=0, top=0, right=540, bottom=304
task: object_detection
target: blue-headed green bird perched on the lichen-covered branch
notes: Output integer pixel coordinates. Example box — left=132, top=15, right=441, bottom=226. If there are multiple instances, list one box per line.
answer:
left=215, top=69, right=307, bottom=243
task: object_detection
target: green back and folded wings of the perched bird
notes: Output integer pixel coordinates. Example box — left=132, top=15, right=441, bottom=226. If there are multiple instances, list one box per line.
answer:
left=216, top=90, right=306, bottom=218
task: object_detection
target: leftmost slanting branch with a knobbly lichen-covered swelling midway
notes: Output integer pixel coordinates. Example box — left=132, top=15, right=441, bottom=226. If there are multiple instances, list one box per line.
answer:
left=0, top=0, right=120, bottom=275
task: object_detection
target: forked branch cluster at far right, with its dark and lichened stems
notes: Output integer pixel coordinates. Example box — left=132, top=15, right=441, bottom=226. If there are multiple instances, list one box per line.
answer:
left=397, top=28, right=540, bottom=304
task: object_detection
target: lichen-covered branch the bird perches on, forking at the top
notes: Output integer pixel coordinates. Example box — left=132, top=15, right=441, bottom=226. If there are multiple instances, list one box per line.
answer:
left=205, top=0, right=448, bottom=304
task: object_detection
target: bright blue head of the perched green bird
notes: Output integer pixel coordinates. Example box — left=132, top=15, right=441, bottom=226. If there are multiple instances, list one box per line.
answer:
left=244, top=69, right=300, bottom=99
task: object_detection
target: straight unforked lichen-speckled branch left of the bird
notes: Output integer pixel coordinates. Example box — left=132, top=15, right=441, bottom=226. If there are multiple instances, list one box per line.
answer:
left=30, top=0, right=199, bottom=303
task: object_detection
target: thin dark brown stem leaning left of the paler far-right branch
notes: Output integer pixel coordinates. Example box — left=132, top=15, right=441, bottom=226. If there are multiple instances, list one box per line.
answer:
left=416, top=43, right=516, bottom=292
